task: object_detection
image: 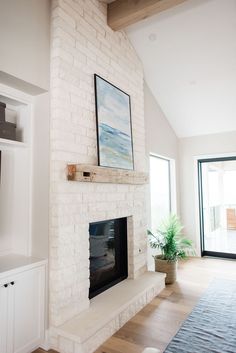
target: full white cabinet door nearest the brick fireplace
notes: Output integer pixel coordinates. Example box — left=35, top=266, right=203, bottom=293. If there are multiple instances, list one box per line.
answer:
left=11, top=267, right=45, bottom=353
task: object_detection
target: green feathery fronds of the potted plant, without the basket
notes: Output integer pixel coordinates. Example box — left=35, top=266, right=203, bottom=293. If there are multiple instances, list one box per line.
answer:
left=148, top=214, right=194, bottom=261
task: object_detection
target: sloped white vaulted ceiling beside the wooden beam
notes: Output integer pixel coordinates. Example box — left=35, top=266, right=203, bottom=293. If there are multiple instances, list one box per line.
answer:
left=127, top=0, right=236, bottom=137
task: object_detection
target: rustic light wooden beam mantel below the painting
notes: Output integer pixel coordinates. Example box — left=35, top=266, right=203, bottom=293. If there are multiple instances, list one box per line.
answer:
left=67, top=164, right=149, bottom=185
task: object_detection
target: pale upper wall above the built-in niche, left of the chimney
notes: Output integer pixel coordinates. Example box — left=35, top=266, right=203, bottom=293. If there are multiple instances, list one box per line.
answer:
left=0, top=0, right=50, bottom=90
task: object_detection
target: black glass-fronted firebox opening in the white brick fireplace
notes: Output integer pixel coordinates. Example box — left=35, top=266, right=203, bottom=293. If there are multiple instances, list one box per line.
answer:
left=89, top=218, right=128, bottom=299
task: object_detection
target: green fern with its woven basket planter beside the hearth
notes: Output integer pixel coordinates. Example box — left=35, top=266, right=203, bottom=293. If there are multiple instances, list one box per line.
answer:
left=148, top=215, right=194, bottom=284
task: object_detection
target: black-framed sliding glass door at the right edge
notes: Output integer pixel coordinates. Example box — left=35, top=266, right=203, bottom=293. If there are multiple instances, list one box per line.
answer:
left=198, top=157, right=236, bottom=258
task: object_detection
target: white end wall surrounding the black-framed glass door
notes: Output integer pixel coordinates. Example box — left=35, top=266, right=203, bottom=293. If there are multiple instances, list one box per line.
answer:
left=179, top=132, right=236, bottom=255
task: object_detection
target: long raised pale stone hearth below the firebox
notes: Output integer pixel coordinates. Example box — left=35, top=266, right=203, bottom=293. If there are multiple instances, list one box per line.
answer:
left=51, top=271, right=165, bottom=353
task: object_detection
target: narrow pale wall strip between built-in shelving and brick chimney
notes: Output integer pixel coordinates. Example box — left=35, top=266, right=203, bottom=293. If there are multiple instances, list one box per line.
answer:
left=32, top=93, right=50, bottom=258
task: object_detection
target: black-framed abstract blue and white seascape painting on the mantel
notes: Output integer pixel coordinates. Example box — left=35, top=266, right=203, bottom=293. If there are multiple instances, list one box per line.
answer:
left=94, top=75, right=133, bottom=169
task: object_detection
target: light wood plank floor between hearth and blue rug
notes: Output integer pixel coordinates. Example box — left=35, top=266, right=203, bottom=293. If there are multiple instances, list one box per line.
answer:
left=34, top=258, right=236, bottom=353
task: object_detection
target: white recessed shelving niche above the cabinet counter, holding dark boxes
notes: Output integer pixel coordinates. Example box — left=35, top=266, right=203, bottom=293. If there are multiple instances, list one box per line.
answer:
left=0, top=84, right=32, bottom=256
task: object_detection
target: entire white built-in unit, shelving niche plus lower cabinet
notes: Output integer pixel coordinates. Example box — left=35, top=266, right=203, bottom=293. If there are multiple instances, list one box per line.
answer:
left=0, top=84, right=47, bottom=353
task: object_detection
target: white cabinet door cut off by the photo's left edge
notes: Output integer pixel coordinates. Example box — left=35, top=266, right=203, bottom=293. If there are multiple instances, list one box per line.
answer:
left=0, top=282, right=9, bottom=353
